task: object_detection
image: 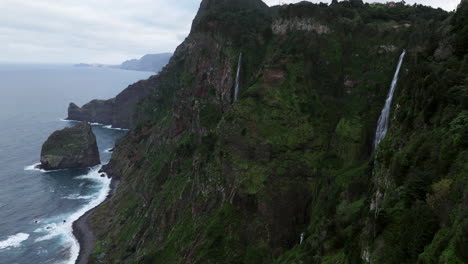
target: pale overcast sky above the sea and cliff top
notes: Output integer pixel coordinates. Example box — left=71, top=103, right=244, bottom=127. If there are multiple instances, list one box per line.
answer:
left=0, top=0, right=460, bottom=64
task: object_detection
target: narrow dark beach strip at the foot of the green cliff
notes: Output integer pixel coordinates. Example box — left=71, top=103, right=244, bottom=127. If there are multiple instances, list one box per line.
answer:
left=72, top=169, right=120, bottom=264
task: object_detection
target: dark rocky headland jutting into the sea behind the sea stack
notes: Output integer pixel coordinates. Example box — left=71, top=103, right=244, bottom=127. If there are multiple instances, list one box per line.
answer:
left=67, top=76, right=157, bottom=128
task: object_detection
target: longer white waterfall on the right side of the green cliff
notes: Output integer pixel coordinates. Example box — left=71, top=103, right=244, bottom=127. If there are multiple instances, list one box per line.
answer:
left=374, top=50, right=406, bottom=150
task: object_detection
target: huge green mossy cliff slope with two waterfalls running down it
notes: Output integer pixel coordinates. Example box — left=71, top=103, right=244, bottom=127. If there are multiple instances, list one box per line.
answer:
left=86, top=0, right=468, bottom=263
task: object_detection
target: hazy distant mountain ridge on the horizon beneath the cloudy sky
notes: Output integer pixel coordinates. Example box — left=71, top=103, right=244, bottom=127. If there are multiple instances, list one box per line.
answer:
left=74, top=53, right=172, bottom=72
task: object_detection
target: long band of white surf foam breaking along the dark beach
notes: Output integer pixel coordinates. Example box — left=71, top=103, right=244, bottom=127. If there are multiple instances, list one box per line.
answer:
left=34, top=166, right=111, bottom=264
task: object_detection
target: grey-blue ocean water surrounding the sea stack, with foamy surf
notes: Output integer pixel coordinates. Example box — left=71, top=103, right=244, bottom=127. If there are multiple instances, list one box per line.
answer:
left=0, top=64, right=152, bottom=264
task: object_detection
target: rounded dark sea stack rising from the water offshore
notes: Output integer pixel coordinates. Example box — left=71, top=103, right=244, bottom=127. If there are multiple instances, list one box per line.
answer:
left=40, top=122, right=101, bottom=170
